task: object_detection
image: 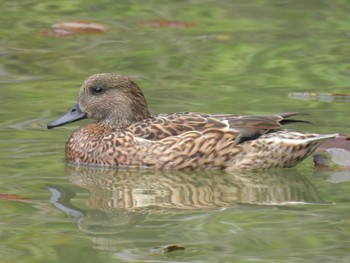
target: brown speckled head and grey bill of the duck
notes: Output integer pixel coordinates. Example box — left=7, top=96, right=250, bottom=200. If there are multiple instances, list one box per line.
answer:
left=47, top=73, right=150, bottom=129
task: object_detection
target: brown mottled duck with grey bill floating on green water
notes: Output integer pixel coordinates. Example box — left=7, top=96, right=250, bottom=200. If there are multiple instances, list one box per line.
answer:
left=47, top=73, right=338, bottom=172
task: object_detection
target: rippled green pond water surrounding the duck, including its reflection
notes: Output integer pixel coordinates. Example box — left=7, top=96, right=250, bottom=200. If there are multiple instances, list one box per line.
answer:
left=0, top=0, right=350, bottom=262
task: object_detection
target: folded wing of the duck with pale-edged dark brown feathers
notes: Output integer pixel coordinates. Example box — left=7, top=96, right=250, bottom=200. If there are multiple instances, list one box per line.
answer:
left=127, top=112, right=305, bottom=141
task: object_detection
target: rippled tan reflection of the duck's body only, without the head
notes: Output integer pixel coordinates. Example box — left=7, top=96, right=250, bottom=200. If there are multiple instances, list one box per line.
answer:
left=66, top=166, right=320, bottom=213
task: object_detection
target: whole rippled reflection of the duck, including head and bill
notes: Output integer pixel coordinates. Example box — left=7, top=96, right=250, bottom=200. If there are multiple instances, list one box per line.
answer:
left=44, top=166, right=322, bottom=251
